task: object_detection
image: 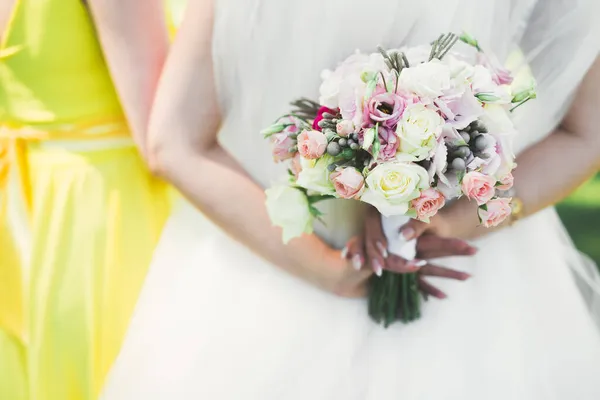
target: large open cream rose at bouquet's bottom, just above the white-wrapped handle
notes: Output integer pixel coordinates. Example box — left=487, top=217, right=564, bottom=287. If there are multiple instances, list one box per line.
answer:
left=361, top=161, right=429, bottom=216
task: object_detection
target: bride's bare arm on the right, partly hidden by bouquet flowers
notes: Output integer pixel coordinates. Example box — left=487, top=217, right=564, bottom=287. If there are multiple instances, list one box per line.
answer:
left=426, top=58, right=600, bottom=239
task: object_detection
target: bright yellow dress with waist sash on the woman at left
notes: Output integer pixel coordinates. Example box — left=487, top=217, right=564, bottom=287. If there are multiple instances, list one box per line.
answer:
left=0, top=0, right=169, bottom=400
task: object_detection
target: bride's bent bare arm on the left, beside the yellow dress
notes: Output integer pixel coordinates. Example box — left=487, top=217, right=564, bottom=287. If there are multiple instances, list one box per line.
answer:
left=148, top=0, right=369, bottom=294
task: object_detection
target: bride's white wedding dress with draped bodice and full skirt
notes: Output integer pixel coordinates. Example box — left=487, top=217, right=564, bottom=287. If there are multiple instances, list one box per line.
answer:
left=102, top=0, right=600, bottom=400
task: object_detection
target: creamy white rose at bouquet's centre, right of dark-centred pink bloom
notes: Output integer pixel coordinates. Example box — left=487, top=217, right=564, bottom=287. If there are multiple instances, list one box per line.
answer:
left=396, top=104, right=444, bottom=161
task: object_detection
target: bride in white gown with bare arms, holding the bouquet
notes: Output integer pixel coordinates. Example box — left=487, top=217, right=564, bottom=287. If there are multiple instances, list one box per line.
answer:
left=103, top=0, right=600, bottom=400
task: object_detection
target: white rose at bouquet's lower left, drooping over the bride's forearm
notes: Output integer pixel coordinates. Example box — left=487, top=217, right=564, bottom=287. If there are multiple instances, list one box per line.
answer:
left=265, top=186, right=314, bottom=243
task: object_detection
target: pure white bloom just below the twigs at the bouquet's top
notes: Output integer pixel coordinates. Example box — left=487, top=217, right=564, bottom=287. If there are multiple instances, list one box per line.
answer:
left=400, top=60, right=451, bottom=98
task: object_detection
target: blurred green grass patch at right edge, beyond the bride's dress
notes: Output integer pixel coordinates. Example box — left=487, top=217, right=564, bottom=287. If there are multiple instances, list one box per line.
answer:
left=556, top=173, right=600, bottom=265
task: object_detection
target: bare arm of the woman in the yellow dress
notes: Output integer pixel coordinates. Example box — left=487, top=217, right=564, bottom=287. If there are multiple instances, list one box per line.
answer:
left=88, top=0, right=169, bottom=156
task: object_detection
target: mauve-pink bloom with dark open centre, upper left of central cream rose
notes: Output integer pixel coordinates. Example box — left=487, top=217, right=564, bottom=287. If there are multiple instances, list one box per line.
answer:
left=363, top=87, right=406, bottom=128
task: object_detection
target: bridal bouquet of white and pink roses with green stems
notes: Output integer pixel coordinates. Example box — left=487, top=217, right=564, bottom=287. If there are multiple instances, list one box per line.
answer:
left=262, top=33, right=536, bottom=326
